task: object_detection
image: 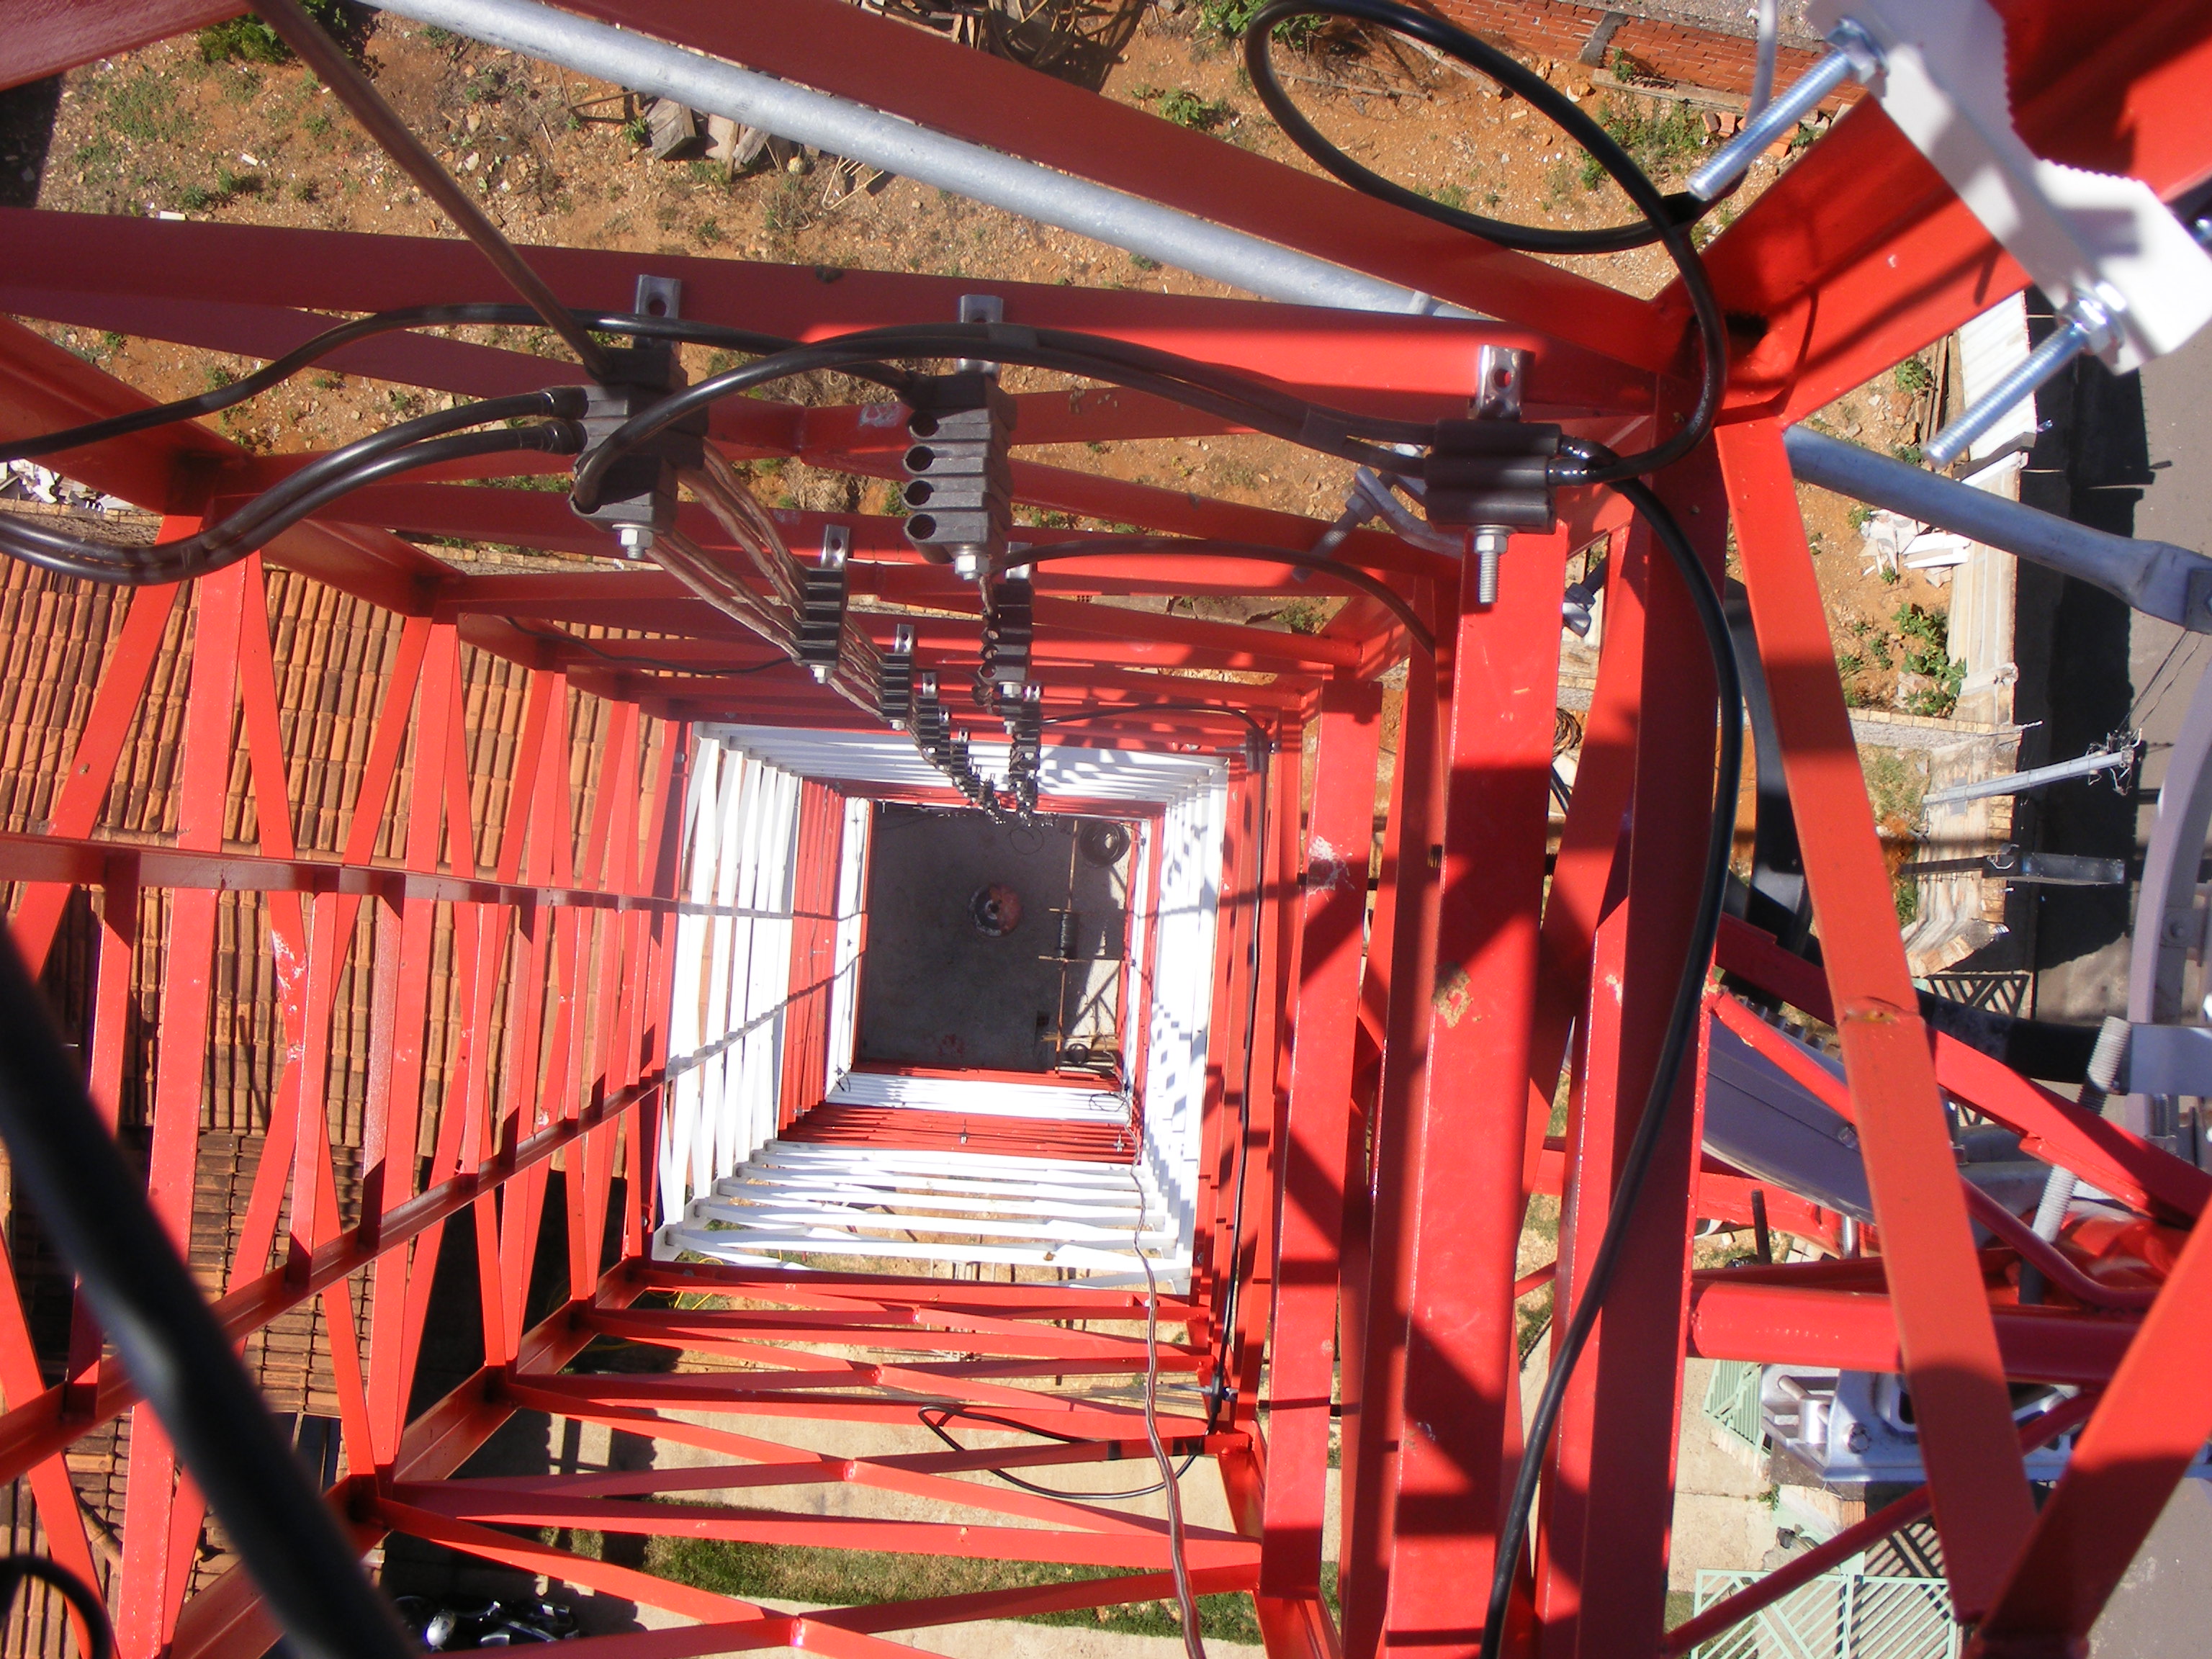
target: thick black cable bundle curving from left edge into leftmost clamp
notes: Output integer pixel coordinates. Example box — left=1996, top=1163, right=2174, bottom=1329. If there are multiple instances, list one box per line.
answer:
left=0, top=387, right=584, bottom=586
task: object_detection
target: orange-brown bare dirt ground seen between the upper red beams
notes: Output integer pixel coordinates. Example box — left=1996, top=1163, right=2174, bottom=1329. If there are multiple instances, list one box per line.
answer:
left=21, top=0, right=1944, bottom=712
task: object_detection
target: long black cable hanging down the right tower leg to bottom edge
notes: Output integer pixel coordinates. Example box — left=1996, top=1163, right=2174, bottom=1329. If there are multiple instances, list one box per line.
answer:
left=1482, top=444, right=1743, bottom=1659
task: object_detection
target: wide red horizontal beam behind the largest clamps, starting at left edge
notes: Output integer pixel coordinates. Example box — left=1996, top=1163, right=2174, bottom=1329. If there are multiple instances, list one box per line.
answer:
left=0, top=209, right=1663, bottom=413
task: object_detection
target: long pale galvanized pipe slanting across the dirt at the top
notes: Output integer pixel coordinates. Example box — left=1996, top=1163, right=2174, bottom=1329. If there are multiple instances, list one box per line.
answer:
left=385, top=0, right=1473, bottom=318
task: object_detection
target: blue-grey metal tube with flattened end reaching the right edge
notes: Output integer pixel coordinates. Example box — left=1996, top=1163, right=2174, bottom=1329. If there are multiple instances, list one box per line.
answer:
left=1783, top=427, right=2212, bottom=633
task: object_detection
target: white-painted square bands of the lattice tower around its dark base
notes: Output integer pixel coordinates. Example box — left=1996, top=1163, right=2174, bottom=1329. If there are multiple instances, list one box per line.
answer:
left=655, top=726, right=1228, bottom=1290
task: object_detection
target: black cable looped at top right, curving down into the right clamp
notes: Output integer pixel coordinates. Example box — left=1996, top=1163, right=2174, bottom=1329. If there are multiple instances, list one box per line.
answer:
left=1246, top=0, right=1727, bottom=485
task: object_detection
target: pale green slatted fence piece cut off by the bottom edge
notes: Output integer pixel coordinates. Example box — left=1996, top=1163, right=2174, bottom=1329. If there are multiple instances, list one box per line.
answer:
left=1692, top=1575, right=1960, bottom=1659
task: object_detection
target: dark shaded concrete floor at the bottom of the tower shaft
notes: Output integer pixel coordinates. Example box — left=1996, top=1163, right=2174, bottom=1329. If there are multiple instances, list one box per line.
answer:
left=858, top=805, right=1130, bottom=1071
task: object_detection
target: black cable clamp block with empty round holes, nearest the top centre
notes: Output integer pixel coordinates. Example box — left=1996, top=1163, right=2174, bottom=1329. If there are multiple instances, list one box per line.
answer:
left=900, top=369, right=1015, bottom=580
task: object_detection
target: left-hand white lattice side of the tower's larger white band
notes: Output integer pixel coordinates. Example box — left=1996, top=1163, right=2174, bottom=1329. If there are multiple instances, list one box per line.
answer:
left=659, top=739, right=799, bottom=1217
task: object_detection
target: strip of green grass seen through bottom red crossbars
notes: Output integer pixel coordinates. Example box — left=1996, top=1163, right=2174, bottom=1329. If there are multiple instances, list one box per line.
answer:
left=646, top=1537, right=1261, bottom=1641
